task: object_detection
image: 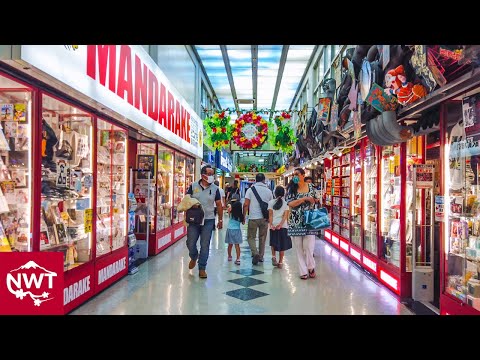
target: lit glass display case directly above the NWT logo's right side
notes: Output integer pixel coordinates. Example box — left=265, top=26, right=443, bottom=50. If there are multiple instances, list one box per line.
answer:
left=39, top=94, right=94, bottom=270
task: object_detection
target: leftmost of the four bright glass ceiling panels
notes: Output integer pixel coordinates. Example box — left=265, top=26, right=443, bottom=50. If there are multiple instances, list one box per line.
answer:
left=195, top=45, right=235, bottom=108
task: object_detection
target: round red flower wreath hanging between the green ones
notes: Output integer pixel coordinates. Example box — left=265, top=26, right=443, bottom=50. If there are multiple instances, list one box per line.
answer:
left=232, top=112, right=268, bottom=149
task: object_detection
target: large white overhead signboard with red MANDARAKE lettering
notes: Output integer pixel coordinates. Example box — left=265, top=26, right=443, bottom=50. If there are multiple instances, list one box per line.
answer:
left=12, top=45, right=203, bottom=158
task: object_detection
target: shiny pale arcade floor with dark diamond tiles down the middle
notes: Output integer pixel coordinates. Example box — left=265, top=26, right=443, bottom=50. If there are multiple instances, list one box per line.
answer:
left=71, top=219, right=412, bottom=315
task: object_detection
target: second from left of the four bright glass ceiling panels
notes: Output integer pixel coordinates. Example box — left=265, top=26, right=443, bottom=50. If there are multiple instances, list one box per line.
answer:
left=227, top=45, right=253, bottom=109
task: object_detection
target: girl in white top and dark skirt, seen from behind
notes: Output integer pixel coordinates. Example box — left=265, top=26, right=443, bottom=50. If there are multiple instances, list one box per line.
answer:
left=268, top=185, right=292, bottom=269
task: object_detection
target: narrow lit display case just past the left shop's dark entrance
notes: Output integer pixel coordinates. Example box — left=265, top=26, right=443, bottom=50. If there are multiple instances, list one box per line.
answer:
left=157, top=145, right=173, bottom=231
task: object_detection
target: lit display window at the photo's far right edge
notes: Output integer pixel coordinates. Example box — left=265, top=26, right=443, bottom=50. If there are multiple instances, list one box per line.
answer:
left=444, top=116, right=480, bottom=310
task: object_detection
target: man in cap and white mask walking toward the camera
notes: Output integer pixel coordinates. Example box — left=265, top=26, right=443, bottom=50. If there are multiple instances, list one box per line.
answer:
left=187, top=165, right=223, bottom=279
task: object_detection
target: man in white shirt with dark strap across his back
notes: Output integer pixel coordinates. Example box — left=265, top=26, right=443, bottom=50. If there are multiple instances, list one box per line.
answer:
left=243, top=173, right=273, bottom=265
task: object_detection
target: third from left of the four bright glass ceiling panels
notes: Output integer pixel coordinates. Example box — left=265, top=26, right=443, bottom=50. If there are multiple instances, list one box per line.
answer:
left=257, top=45, right=283, bottom=109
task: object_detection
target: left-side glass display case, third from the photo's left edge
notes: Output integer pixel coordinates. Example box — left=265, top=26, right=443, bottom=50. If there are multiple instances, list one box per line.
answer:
left=96, top=119, right=127, bottom=257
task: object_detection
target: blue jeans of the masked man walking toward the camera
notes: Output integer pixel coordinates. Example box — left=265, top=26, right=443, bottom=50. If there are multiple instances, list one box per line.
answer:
left=187, top=219, right=215, bottom=270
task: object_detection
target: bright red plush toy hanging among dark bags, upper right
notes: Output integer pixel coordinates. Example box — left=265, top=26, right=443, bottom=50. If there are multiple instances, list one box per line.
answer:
left=385, top=65, right=427, bottom=105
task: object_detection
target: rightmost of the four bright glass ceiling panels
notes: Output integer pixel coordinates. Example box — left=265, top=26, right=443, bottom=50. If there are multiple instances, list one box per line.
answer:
left=275, top=45, right=315, bottom=110
